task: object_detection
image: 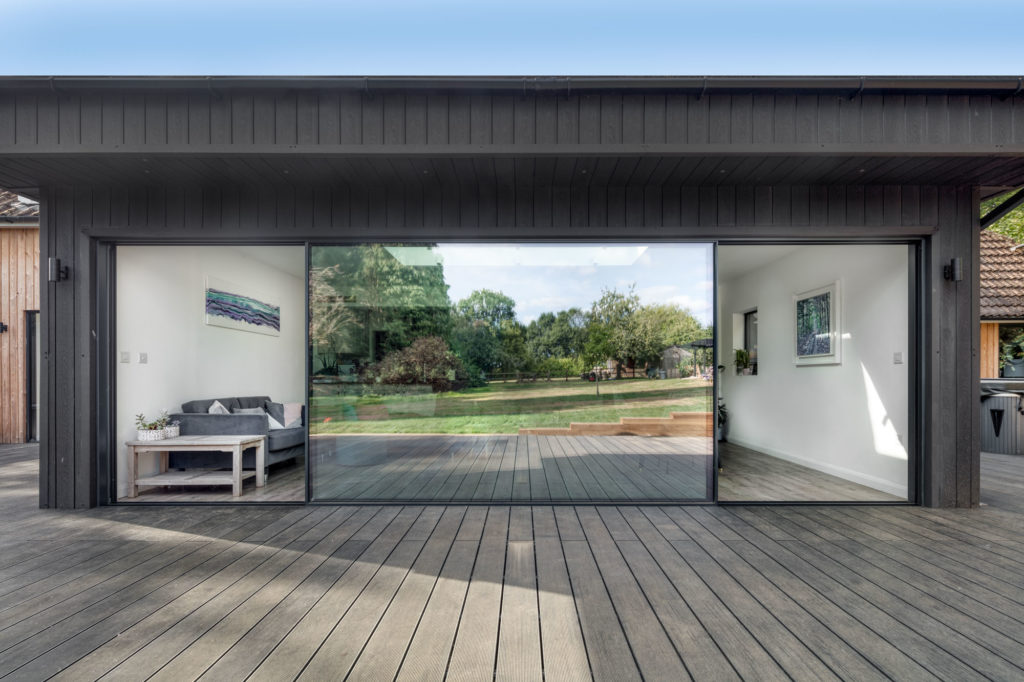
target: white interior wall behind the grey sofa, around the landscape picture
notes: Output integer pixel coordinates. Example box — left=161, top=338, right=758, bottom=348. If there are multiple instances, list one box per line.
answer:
left=116, top=246, right=306, bottom=497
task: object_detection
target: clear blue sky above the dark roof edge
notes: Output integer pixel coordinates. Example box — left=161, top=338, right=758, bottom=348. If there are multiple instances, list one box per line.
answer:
left=0, top=0, right=1024, bottom=75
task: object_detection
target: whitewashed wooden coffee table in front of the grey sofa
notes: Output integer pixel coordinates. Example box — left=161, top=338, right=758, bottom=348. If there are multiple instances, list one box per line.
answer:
left=125, top=435, right=266, bottom=498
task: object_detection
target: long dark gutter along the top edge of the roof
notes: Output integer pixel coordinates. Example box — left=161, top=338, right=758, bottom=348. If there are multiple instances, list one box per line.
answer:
left=0, top=76, right=1024, bottom=98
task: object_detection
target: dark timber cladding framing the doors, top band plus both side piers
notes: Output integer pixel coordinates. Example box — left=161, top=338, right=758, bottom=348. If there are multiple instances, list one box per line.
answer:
left=40, top=183, right=980, bottom=508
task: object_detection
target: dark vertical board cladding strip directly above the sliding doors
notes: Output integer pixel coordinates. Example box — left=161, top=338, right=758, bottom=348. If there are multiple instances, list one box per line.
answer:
left=66, top=178, right=939, bottom=237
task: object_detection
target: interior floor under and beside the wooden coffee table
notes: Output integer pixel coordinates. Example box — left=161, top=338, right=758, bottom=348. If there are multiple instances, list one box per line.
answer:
left=118, top=459, right=306, bottom=504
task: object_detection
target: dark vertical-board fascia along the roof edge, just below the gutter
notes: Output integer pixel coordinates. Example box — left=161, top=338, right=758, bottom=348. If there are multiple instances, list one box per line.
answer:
left=6, top=89, right=1024, bottom=152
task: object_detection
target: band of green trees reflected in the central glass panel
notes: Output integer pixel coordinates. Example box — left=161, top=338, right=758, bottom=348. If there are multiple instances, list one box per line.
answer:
left=309, top=244, right=710, bottom=386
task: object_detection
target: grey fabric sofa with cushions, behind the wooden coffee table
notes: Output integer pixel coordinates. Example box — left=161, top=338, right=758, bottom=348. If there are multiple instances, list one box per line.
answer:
left=168, top=395, right=306, bottom=469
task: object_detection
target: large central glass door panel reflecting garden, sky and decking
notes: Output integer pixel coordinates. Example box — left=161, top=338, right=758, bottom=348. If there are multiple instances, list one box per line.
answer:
left=309, top=244, right=713, bottom=502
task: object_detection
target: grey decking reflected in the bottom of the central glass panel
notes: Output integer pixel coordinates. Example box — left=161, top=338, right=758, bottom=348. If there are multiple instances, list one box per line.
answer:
left=310, top=434, right=713, bottom=503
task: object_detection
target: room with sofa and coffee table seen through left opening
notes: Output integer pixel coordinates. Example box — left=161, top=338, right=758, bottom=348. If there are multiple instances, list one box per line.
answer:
left=115, top=246, right=306, bottom=503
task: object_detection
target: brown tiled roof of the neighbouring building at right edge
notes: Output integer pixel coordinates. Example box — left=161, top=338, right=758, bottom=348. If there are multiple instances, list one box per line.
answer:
left=979, top=229, right=1024, bottom=319
